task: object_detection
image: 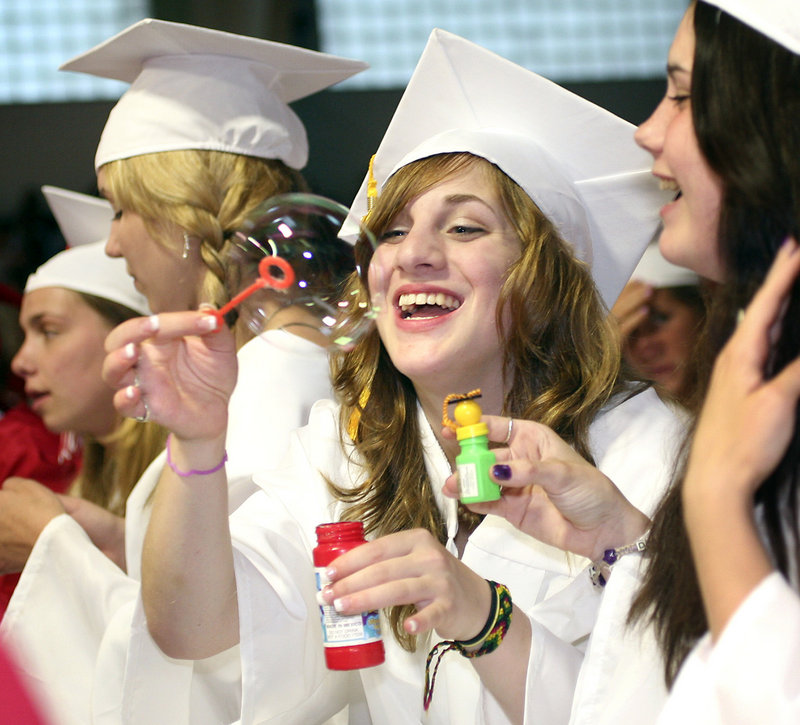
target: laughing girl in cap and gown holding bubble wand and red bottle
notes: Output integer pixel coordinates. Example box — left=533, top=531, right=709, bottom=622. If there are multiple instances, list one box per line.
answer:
left=106, top=30, right=679, bottom=723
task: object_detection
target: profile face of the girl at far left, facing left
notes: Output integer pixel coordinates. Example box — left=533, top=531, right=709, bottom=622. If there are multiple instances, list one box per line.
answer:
left=11, top=287, right=117, bottom=438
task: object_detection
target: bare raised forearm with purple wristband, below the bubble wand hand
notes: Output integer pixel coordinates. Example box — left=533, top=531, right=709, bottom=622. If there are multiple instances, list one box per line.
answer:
left=142, top=434, right=239, bottom=659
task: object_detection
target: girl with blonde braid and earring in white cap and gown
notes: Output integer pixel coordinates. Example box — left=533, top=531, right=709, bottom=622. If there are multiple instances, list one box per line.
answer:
left=0, top=19, right=366, bottom=725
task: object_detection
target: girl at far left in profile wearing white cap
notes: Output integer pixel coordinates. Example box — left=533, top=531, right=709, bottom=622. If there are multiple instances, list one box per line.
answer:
left=0, top=187, right=165, bottom=611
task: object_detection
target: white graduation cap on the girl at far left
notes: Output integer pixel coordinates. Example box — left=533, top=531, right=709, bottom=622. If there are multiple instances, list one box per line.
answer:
left=25, top=186, right=150, bottom=315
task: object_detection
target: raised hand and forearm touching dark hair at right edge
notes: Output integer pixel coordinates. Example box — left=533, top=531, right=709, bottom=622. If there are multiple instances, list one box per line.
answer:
left=682, top=240, right=800, bottom=639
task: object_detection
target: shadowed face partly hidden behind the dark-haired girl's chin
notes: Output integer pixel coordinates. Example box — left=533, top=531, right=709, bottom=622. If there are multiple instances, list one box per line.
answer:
left=625, top=289, right=702, bottom=395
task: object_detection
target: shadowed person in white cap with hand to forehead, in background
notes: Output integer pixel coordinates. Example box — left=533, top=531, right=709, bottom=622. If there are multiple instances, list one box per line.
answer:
left=611, top=243, right=706, bottom=407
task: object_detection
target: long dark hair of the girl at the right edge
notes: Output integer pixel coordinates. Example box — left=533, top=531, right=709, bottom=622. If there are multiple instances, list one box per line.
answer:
left=630, top=2, right=800, bottom=686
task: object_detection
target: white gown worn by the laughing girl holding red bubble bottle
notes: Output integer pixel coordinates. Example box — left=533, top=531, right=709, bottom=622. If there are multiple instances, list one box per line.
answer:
left=217, top=391, right=681, bottom=725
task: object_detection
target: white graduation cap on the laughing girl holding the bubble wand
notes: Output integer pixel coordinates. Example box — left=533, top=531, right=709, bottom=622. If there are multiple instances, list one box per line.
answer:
left=346, top=29, right=668, bottom=307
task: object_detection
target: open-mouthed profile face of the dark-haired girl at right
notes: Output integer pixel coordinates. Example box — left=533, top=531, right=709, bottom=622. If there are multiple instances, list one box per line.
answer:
left=635, top=6, right=723, bottom=282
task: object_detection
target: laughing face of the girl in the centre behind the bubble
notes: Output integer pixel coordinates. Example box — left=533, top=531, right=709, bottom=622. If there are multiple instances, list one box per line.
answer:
left=370, top=164, right=521, bottom=392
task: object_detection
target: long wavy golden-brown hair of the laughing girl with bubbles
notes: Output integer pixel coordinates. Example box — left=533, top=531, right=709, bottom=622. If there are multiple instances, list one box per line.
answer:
left=332, top=153, right=626, bottom=651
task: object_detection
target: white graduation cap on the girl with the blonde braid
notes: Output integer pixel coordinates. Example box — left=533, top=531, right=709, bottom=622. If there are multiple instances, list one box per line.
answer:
left=60, top=18, right=367, bottom=169
